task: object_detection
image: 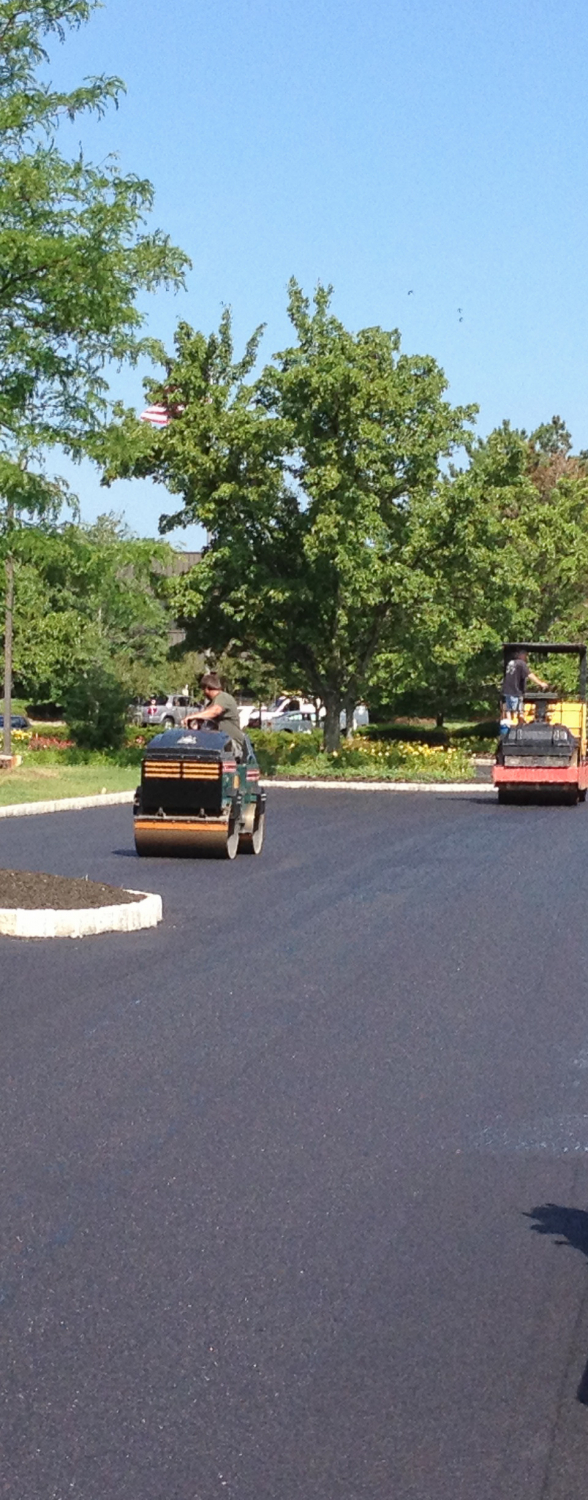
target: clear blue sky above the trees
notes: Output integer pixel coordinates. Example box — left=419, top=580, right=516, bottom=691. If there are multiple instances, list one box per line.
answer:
left=51, top=0, right=588, bottom=545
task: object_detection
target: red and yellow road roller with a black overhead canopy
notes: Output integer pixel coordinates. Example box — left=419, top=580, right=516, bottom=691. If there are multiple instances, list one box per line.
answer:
left=492, top=641, right=588, bottom=804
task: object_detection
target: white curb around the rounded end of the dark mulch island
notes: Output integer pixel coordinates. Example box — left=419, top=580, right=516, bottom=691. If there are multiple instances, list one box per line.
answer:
left=0, top=891, right=164, bottom=938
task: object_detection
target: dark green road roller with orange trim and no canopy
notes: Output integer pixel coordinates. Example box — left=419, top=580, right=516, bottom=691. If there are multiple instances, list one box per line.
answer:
left=134, top=729, right=266, bottom=860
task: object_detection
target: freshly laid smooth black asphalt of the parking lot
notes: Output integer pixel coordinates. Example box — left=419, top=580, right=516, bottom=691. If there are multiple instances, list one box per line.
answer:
left=0, top=788, right=588, bottom=1500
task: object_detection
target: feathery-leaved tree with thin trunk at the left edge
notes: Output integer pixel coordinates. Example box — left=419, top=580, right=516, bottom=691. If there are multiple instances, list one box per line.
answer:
left=0, top=0, right=188, bottom=750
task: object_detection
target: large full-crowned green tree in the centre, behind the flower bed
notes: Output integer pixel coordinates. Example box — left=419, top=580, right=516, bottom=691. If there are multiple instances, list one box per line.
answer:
left=111, top=281, right=474, bottom=749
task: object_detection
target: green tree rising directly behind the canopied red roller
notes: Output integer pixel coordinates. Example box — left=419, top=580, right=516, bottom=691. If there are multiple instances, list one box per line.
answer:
left=372, top=417, right=588, bottom=716
